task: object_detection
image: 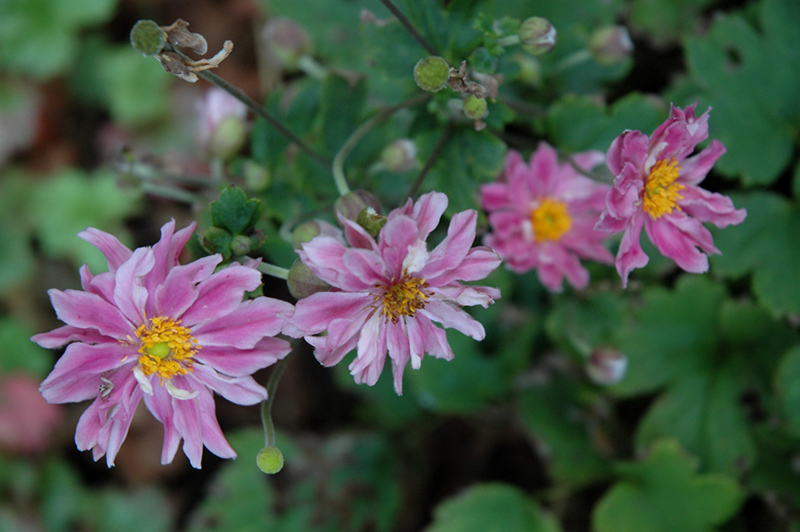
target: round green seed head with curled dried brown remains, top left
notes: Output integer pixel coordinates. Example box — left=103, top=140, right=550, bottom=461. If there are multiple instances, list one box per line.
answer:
left=131, top=19, right=233, bottom=83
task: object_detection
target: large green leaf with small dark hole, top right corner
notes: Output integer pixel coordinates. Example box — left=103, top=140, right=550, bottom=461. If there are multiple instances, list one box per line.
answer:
left=684, top=0, right=800, bottom=186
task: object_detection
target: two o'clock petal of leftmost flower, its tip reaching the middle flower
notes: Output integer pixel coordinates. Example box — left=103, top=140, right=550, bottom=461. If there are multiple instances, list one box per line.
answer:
left=192, top=297, right=291, bottom=349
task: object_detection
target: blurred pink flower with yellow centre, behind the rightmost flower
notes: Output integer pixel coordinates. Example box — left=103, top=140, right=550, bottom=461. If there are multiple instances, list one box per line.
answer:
left=481, top=142, right=614, bottom=292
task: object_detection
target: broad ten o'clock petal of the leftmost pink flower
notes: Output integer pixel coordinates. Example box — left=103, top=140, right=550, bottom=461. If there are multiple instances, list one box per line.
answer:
left=47, top=289, right=136, bottom=340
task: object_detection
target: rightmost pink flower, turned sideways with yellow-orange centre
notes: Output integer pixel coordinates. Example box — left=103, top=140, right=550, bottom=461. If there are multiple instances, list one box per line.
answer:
left=597, top=104, right=747, bottom=286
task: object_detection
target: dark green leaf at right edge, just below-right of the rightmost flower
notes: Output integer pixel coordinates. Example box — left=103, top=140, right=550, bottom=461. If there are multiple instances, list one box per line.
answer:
left=711, top=192, right=800, bottom=315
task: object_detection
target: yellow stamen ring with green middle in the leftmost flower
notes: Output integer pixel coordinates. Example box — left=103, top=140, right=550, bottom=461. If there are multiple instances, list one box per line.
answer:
left=136, top=316, right=201, bottom=384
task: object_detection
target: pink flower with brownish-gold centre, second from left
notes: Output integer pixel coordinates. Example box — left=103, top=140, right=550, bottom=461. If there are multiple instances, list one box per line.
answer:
left=289, top=193, right=500, bottom=394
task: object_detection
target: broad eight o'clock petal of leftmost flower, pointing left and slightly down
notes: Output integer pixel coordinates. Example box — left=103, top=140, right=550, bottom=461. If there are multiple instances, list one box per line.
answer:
left=40, top=342, right=139, bottom=403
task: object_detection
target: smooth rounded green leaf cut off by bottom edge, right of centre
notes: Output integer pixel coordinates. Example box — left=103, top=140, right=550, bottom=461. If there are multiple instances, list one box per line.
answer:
left=425, top=483, right=561, bottom=532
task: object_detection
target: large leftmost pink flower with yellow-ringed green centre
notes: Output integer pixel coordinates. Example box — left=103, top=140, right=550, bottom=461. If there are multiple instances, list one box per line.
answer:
left=32, top=221, right=292, bottom=468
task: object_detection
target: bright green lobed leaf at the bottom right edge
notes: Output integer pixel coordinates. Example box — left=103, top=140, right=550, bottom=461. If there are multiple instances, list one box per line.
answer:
left=592, top=440, right=744, bottom=532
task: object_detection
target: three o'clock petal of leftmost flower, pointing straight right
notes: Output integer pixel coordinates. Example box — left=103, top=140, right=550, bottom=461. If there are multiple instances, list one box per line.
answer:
left=194, top=336, right=292, bottom=377
